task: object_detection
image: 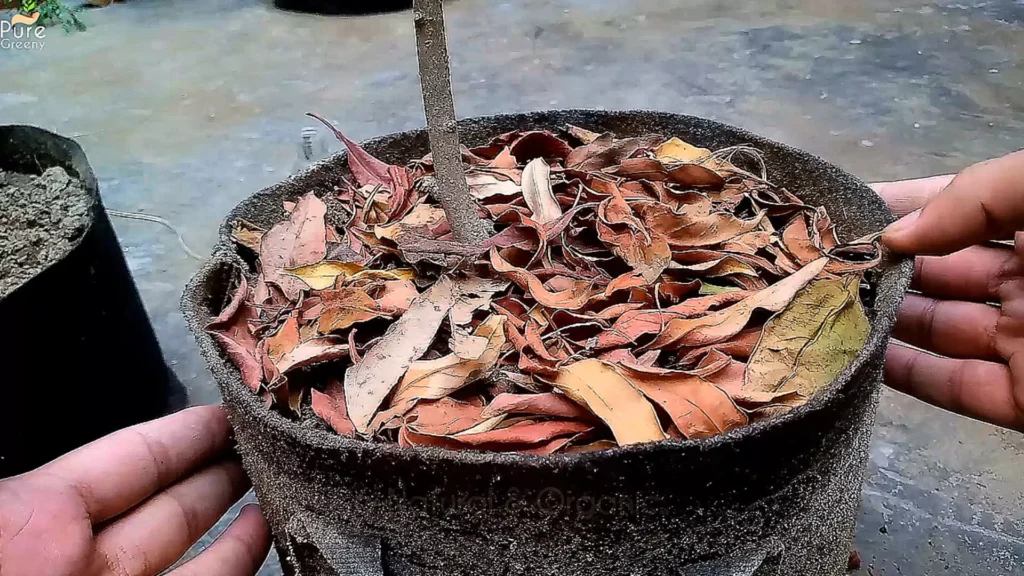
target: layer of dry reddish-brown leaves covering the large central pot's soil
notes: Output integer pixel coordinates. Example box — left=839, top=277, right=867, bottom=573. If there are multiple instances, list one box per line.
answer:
left=209, top=122, right=881, bottom=454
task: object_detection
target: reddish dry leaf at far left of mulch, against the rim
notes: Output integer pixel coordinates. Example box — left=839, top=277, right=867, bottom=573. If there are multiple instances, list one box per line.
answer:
left=206, top=276, right=263, bottom=390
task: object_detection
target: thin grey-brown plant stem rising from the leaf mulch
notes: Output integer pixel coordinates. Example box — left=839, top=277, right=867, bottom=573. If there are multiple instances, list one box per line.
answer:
left=413, top=0, right=494, bottom=244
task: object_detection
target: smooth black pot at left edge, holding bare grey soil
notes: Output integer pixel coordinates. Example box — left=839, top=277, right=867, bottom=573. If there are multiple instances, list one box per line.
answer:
left=0, top=126, right=182, bottom=478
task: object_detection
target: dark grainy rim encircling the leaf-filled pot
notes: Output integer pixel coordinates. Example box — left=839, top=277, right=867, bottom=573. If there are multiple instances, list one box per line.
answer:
left=182, top=109, right=913, bottom=468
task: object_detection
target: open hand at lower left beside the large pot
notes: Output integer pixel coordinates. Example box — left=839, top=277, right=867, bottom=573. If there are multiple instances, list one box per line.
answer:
left=0, top=406, right=270, bottom=576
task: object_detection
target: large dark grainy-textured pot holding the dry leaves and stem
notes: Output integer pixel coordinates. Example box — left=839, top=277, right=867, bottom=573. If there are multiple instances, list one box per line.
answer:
left=182, top=111, right=912, bottom=576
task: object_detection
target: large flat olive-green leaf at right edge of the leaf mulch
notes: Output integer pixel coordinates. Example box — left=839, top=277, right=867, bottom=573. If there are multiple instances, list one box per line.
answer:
left=743, top=274, right=870, bottom=397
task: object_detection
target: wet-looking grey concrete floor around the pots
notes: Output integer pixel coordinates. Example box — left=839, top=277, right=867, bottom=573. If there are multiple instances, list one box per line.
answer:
left=0, top=0, right=1024, bottom=575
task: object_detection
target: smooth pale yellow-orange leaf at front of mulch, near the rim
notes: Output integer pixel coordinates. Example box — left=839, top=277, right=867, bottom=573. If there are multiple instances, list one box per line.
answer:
left=552, top=359, right=665, bottom=446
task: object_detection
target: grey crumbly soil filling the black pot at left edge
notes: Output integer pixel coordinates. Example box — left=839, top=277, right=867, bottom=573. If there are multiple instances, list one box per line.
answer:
left=0, top=167, right=92, bottom=297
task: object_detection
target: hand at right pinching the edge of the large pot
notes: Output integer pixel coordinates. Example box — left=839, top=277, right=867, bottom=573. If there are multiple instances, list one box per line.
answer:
left=874, top=151, right=1024, bottom=430
